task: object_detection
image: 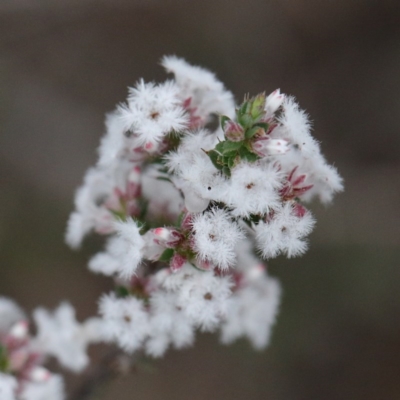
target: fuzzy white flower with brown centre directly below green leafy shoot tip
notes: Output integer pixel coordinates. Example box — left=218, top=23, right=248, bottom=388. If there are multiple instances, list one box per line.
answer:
left=221, top=162, right=282, bottom=217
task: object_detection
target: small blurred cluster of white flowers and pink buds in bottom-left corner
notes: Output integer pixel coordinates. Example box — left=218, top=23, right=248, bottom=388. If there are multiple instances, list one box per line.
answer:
left=0, top=297, right=100, bottom=400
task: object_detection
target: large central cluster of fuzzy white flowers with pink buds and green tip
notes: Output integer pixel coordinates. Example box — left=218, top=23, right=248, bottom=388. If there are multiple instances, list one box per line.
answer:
left=65, top=57, right=342, bottom=356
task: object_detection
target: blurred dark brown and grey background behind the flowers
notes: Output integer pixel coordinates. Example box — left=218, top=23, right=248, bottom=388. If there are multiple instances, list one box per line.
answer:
left=0, top=0, right=400, bottom=400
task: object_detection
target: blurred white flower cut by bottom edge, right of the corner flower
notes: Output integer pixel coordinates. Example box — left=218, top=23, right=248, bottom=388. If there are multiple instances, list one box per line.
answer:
left=19, top=374, right=65, bottom=400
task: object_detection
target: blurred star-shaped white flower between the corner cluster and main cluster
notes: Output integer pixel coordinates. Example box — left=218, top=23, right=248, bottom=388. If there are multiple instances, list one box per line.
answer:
left=33, top=303, right=95, bottom=372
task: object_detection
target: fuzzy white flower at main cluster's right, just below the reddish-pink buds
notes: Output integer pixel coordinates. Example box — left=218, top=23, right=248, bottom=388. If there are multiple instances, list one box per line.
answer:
left=254, top=202, right=315, bottom=258
